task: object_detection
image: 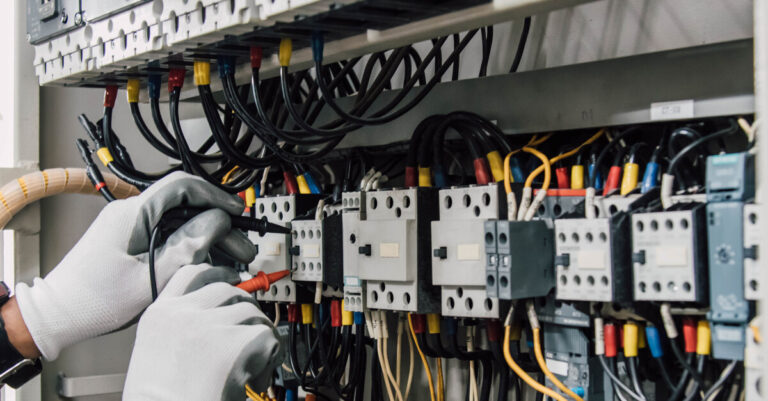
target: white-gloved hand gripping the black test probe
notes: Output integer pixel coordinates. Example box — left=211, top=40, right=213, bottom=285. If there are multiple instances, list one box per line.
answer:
left=16, top=173, right=256, bottom=360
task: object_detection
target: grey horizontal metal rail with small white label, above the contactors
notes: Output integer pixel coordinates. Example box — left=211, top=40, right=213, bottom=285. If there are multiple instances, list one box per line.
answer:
left=332, top=40, right=754, bottom=147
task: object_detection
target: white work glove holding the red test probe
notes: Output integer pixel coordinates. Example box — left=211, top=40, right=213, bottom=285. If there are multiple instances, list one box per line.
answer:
left=123, top=265, right=283, bottom=401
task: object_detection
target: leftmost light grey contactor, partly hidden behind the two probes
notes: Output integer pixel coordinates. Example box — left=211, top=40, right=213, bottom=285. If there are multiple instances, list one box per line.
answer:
left=249, top=195, right=320, bottom=302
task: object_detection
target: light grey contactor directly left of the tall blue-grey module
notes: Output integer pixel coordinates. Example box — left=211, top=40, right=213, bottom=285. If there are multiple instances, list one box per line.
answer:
left=632, top=204, right=708, bottom=303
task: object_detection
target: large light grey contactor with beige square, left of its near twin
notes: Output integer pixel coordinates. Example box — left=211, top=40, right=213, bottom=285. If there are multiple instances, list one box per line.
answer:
left=356, top=188, right=440, bottom=313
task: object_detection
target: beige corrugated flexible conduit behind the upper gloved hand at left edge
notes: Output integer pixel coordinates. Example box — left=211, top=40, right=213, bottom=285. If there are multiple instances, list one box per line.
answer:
left=0, top=168, right=139, bottom=230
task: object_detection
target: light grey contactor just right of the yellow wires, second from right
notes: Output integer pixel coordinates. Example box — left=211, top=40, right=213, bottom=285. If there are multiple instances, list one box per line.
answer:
left=555, top=211, right=632, bottom=302
